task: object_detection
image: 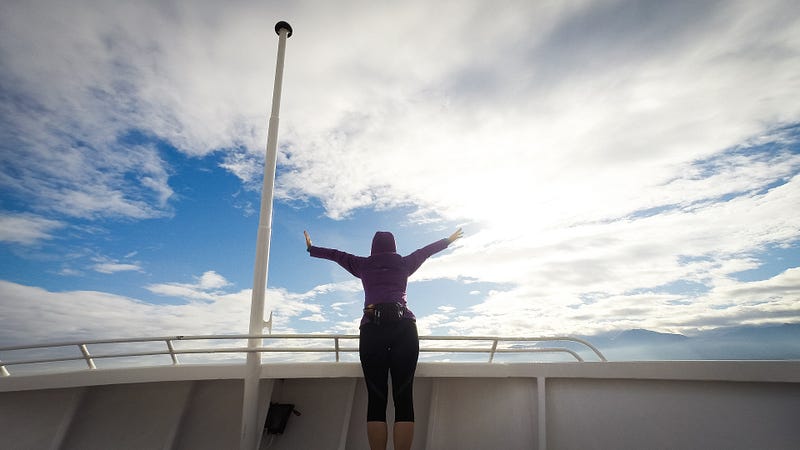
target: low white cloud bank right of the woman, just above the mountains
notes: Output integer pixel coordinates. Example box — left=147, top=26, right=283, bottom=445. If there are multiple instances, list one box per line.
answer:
left=412, top=268, right=800, bottom=336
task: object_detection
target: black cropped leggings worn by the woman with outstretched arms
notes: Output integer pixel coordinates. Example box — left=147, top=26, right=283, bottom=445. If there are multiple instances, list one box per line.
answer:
left=358, top=319, right=419, bottom=422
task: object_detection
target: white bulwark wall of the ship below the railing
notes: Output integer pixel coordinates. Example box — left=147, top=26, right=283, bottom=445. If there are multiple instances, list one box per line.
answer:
left=0, top=361, right=800, bottom=449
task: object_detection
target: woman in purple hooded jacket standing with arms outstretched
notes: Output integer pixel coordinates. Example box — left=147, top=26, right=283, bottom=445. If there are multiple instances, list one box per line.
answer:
left=303, top=228, right=463, bottom=450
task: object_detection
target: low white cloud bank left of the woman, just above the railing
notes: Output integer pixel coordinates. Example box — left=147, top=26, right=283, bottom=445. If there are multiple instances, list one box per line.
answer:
left=0, top=272, right=338, bottom=345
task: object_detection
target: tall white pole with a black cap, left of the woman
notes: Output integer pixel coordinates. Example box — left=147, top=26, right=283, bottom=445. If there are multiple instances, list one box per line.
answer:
left=239, top=22, right=292, bottom=450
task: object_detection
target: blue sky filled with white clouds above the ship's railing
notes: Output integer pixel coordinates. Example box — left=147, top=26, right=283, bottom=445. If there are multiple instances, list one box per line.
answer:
left=0, top=0, right=800, bottom=358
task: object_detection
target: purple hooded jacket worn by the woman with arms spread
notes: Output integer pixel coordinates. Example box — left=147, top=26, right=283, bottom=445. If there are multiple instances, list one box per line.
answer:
left=309, top=231, right=450, bottom=325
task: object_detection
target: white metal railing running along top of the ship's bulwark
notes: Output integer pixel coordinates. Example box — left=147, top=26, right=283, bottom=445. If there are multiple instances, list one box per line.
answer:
left=0, top=334, right=606, bottom=377
